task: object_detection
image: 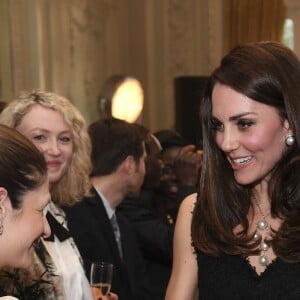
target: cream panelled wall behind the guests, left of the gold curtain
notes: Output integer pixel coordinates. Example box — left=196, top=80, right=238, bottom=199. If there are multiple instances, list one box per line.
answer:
left=0, top=0, right=222, bottom=130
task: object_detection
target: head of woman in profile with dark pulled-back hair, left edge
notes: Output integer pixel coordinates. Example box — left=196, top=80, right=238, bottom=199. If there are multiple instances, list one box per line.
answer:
left=0, top=125, right=50, bottom=268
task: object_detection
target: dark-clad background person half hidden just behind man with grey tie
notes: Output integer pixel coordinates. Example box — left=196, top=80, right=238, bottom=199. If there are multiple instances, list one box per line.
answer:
left=118, top=124, right=174, bottom=300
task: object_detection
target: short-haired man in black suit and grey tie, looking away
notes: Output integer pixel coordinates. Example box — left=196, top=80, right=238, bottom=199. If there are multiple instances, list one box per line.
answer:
left=65, top=119, right=149, bottom=300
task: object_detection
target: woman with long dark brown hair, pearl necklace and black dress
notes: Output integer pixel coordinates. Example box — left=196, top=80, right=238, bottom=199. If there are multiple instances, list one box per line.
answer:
left=166, top=42, right=300, bottom=300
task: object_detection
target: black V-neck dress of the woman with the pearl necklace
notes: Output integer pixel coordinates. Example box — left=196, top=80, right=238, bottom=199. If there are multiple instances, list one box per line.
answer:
left=197, top=253, right=300, bottom=300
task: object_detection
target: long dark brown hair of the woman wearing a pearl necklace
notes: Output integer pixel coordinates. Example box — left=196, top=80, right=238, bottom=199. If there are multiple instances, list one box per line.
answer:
left=192, top=42, right=300, bottom=262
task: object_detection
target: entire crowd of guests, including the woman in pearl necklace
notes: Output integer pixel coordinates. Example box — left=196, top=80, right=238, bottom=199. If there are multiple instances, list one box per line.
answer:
left=0, top=42, right=300, bottom=300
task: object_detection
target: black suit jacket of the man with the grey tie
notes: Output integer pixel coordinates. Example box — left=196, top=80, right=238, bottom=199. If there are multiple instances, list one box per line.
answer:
left=64, top=189, right=151, bottom=300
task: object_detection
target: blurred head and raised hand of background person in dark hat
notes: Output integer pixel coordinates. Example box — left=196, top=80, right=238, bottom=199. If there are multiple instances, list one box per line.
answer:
left=154, top=129, right=202, bottom=223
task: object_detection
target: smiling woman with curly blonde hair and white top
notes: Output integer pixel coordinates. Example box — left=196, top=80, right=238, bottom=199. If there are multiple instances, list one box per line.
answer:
left=0, top=90, right=116, bottom=300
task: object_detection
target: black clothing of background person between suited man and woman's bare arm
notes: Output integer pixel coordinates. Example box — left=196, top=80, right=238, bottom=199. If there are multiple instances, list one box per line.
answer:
left=117, top=190, right=180, bottom=300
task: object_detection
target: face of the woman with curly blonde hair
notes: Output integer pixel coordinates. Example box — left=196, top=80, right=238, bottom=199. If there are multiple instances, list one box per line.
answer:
left=16, top=104, right=73, bottom=184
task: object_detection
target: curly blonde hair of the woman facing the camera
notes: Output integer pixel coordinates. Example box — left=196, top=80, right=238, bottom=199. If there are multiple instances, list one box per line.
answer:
left=0, top=90, right=91, bottom=206
